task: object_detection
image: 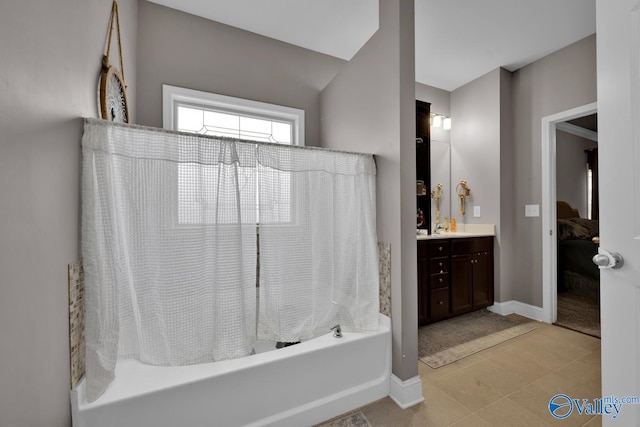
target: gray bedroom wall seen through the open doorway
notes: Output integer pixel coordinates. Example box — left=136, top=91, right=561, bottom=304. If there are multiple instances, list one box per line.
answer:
left=556, top=130, right=598, bottom=218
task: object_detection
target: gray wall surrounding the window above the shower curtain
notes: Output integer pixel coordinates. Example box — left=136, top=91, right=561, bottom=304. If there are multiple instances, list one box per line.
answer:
left=137, top=0, right=345, bottom=145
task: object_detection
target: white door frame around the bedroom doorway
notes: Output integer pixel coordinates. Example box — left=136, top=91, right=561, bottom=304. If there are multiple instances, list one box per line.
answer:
left=541, top=102, right=598, bottom=323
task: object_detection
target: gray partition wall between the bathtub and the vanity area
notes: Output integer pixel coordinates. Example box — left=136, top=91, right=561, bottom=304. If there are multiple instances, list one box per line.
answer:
left=321, top=0, right=418, bottom=380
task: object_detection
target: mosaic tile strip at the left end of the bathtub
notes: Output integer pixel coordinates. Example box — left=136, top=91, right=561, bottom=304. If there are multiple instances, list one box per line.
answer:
left=68, top=261, right=85, bottom=388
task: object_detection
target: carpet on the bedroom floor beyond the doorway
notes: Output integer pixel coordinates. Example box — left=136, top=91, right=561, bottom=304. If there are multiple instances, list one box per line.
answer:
left=555, top=292, right=600, bottom=338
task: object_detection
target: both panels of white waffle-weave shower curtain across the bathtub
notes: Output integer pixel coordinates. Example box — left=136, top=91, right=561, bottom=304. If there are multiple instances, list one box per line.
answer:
left=81, top=119, right=378, bottom=401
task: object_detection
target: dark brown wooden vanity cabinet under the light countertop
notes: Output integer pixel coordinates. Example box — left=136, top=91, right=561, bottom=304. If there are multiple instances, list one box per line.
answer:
left=418, top=237, right=493, bottom=326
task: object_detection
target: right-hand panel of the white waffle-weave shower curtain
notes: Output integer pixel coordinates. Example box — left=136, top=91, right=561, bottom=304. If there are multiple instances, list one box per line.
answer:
left=258, top=146, right=379, bottom=342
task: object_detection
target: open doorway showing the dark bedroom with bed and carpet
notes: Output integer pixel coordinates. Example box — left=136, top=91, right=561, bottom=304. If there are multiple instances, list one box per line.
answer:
left=555, top=114, right=600, bottom=338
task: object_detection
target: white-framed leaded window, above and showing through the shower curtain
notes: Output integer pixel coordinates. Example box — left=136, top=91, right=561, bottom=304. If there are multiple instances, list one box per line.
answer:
left=163, top=85, right=304, bottom=225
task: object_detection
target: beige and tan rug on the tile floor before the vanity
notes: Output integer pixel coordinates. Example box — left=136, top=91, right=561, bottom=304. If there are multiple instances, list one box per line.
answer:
left=418, top=309, right=535, bottom=368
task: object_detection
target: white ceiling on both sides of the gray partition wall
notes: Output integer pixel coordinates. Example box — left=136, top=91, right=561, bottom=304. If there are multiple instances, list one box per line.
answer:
left=150, top=0, right=596, bottom=91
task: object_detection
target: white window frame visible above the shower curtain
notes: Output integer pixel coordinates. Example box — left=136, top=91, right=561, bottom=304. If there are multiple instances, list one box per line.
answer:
left=162, top=84, right=305, bottom=145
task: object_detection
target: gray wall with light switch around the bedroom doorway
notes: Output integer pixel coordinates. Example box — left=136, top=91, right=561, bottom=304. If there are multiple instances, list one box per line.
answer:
left=508, top=34, right=597, bottom=307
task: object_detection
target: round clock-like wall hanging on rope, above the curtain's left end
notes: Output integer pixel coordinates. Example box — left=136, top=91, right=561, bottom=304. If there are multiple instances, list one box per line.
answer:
left=100, top=0, right=129, bottom=123
